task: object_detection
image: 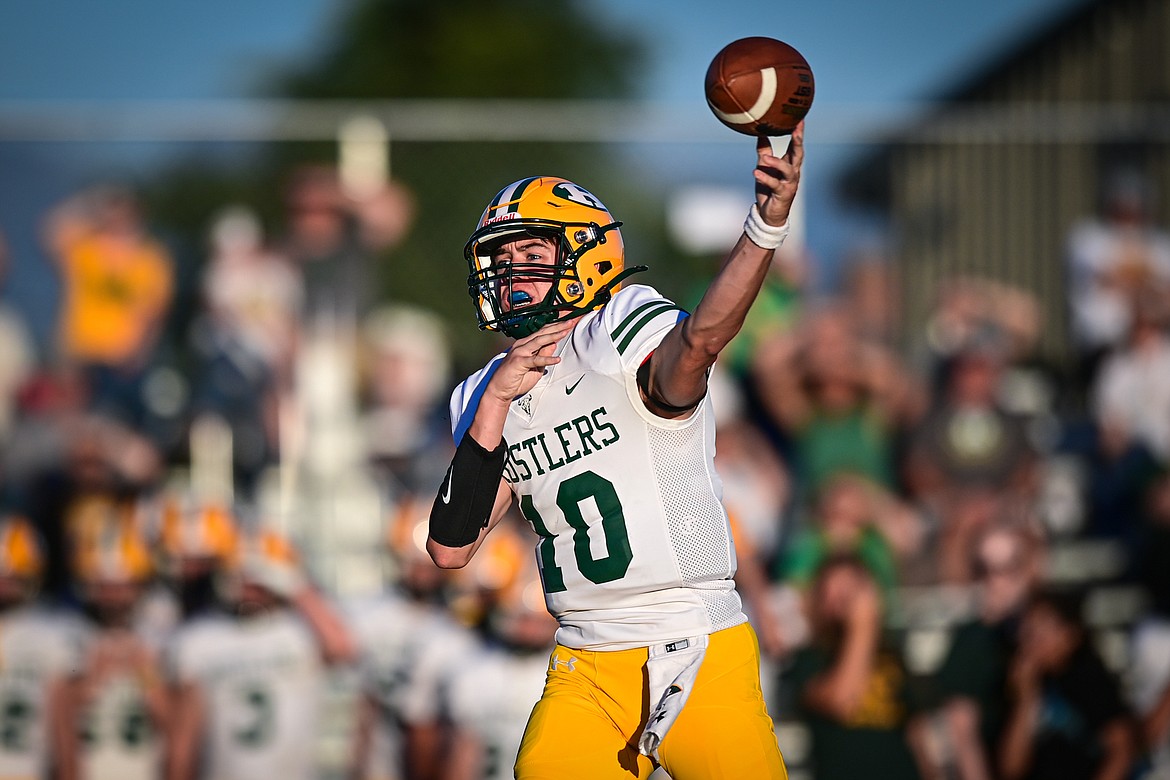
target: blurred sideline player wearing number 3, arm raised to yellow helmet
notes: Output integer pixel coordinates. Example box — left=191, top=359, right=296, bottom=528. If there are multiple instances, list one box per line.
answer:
left=167, top=530, right=355, bottom=780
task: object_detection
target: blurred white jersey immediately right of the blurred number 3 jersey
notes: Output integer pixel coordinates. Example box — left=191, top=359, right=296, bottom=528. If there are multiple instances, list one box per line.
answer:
left=346, top=593, right=479, bottom=778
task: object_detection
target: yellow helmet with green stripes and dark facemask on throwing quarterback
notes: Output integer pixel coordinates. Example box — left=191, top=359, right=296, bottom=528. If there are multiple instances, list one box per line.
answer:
left=463, top=177, right=646, bottom=338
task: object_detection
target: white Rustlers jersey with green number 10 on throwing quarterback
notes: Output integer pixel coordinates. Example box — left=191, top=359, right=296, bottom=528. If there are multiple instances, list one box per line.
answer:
left=450, top=285, right=746, bottom=650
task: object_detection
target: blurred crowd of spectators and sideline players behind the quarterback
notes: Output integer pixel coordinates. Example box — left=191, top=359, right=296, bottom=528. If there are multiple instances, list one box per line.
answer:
left=0, top=167, right=1170, bottom=780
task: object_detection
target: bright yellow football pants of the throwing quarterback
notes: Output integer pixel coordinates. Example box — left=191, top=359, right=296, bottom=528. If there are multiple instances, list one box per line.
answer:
left=516, top=623, right=787, bottom=780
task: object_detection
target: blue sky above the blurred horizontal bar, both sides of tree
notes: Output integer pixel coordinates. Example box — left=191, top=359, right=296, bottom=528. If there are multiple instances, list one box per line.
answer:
left=0, top=0, right=1076, bottom=102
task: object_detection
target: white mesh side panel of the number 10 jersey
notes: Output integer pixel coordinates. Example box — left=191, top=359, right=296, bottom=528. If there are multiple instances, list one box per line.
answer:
left=649, top=421, right=743, bottom=630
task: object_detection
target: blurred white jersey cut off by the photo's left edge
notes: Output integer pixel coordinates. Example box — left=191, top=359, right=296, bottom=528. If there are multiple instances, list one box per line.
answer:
left=0, top=607, right=81, bottom=780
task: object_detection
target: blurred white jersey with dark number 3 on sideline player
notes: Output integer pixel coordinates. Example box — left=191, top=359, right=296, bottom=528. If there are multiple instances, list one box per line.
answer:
left=170, top=609, right=324, bottom=780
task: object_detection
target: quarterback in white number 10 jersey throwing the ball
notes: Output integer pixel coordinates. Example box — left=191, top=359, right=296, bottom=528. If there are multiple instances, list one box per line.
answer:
left=427, top=126, right=804, bottom=780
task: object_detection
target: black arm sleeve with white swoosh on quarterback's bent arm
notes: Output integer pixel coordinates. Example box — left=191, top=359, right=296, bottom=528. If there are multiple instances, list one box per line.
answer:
left=431, top=434, right=508, bottom=547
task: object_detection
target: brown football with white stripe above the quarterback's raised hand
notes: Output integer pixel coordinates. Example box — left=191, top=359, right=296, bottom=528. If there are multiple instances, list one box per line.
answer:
left=704, top=36, right=814, bottom=136
